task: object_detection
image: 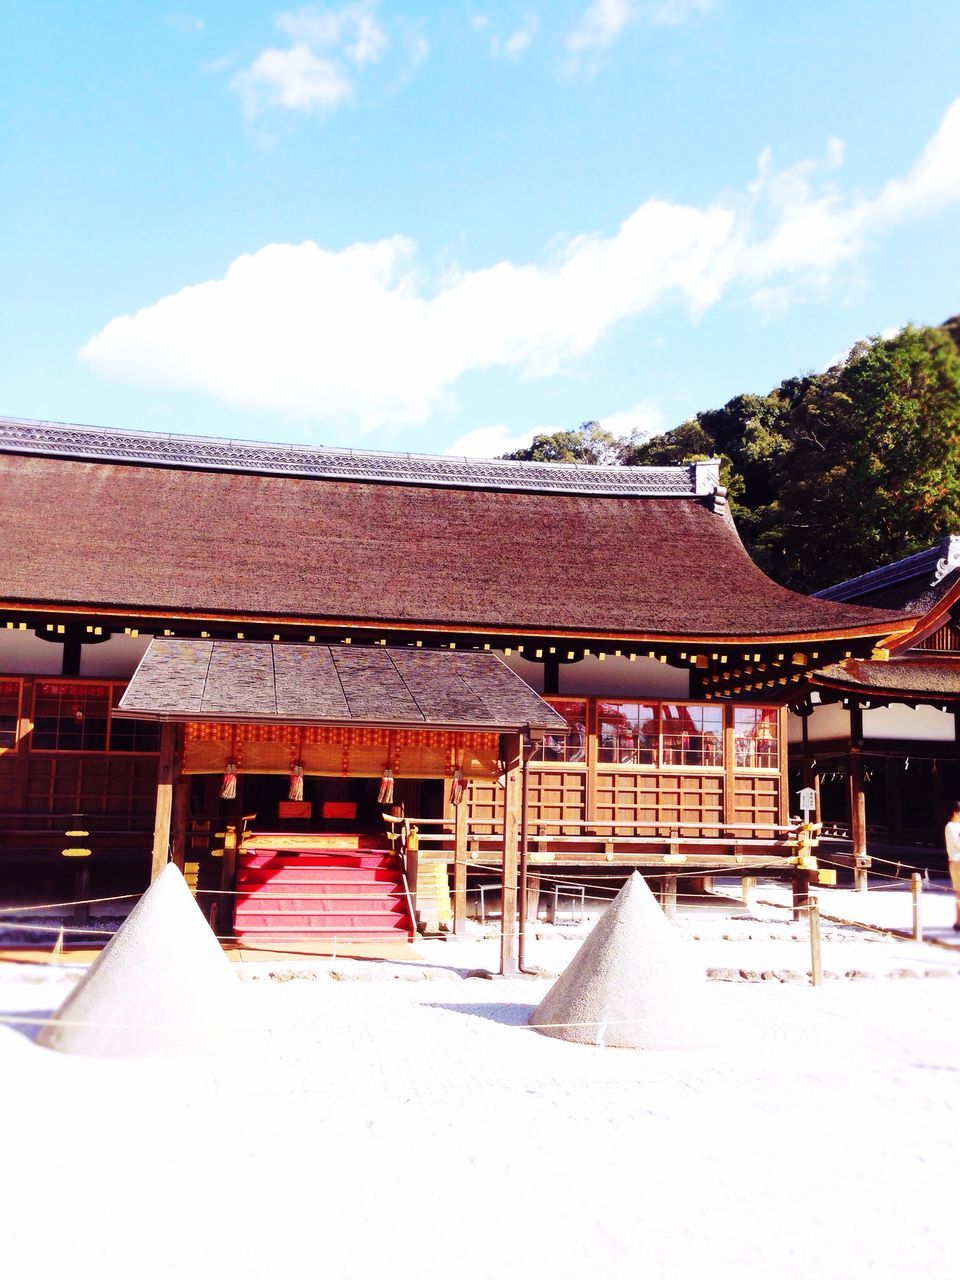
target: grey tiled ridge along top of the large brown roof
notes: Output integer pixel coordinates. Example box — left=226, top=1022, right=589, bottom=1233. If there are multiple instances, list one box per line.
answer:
left=0, top=417, right=719, bottom=499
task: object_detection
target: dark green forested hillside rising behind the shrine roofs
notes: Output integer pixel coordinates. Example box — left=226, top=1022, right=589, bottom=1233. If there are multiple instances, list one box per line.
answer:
left=507, top=316, right=960, bottom=591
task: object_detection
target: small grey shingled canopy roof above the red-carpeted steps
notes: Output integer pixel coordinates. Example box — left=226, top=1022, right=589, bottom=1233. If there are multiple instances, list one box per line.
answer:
left=115, top=637, right=567, bottom=733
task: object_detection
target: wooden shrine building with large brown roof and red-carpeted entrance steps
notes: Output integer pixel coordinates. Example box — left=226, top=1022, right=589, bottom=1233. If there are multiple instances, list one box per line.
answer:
left=0, top=419, right=918, bottom=957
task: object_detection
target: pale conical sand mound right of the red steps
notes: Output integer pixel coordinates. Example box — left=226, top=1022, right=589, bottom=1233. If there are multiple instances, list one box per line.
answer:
left=530, top=872, right=710, bottom=1048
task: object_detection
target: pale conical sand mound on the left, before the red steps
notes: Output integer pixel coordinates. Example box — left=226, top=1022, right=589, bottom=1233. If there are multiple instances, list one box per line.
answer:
left=37, top=864, right=239, bottom=1057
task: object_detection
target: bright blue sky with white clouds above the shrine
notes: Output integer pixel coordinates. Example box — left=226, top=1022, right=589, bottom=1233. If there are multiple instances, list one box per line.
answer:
left=0, top=0, right=960, bottom=456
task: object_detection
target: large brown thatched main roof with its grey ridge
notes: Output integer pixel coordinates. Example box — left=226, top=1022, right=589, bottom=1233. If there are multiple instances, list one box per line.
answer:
left=0, top=420, right=906, bottom=643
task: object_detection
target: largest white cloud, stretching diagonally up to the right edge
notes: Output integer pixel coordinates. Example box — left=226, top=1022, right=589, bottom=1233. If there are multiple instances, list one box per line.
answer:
left=82, top=99, right=960, bottom=435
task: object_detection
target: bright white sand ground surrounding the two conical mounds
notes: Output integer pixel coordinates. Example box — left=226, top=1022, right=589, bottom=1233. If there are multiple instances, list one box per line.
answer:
left=0, top=913, right=960, bottom=1280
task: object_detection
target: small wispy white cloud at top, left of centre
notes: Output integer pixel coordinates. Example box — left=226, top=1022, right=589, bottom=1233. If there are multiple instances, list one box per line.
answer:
left=230, top=0, right=388, bottom=116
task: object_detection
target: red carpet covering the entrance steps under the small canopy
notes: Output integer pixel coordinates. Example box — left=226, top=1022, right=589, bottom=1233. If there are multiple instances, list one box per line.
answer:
left=234, top=836, right=415, bottom=942
